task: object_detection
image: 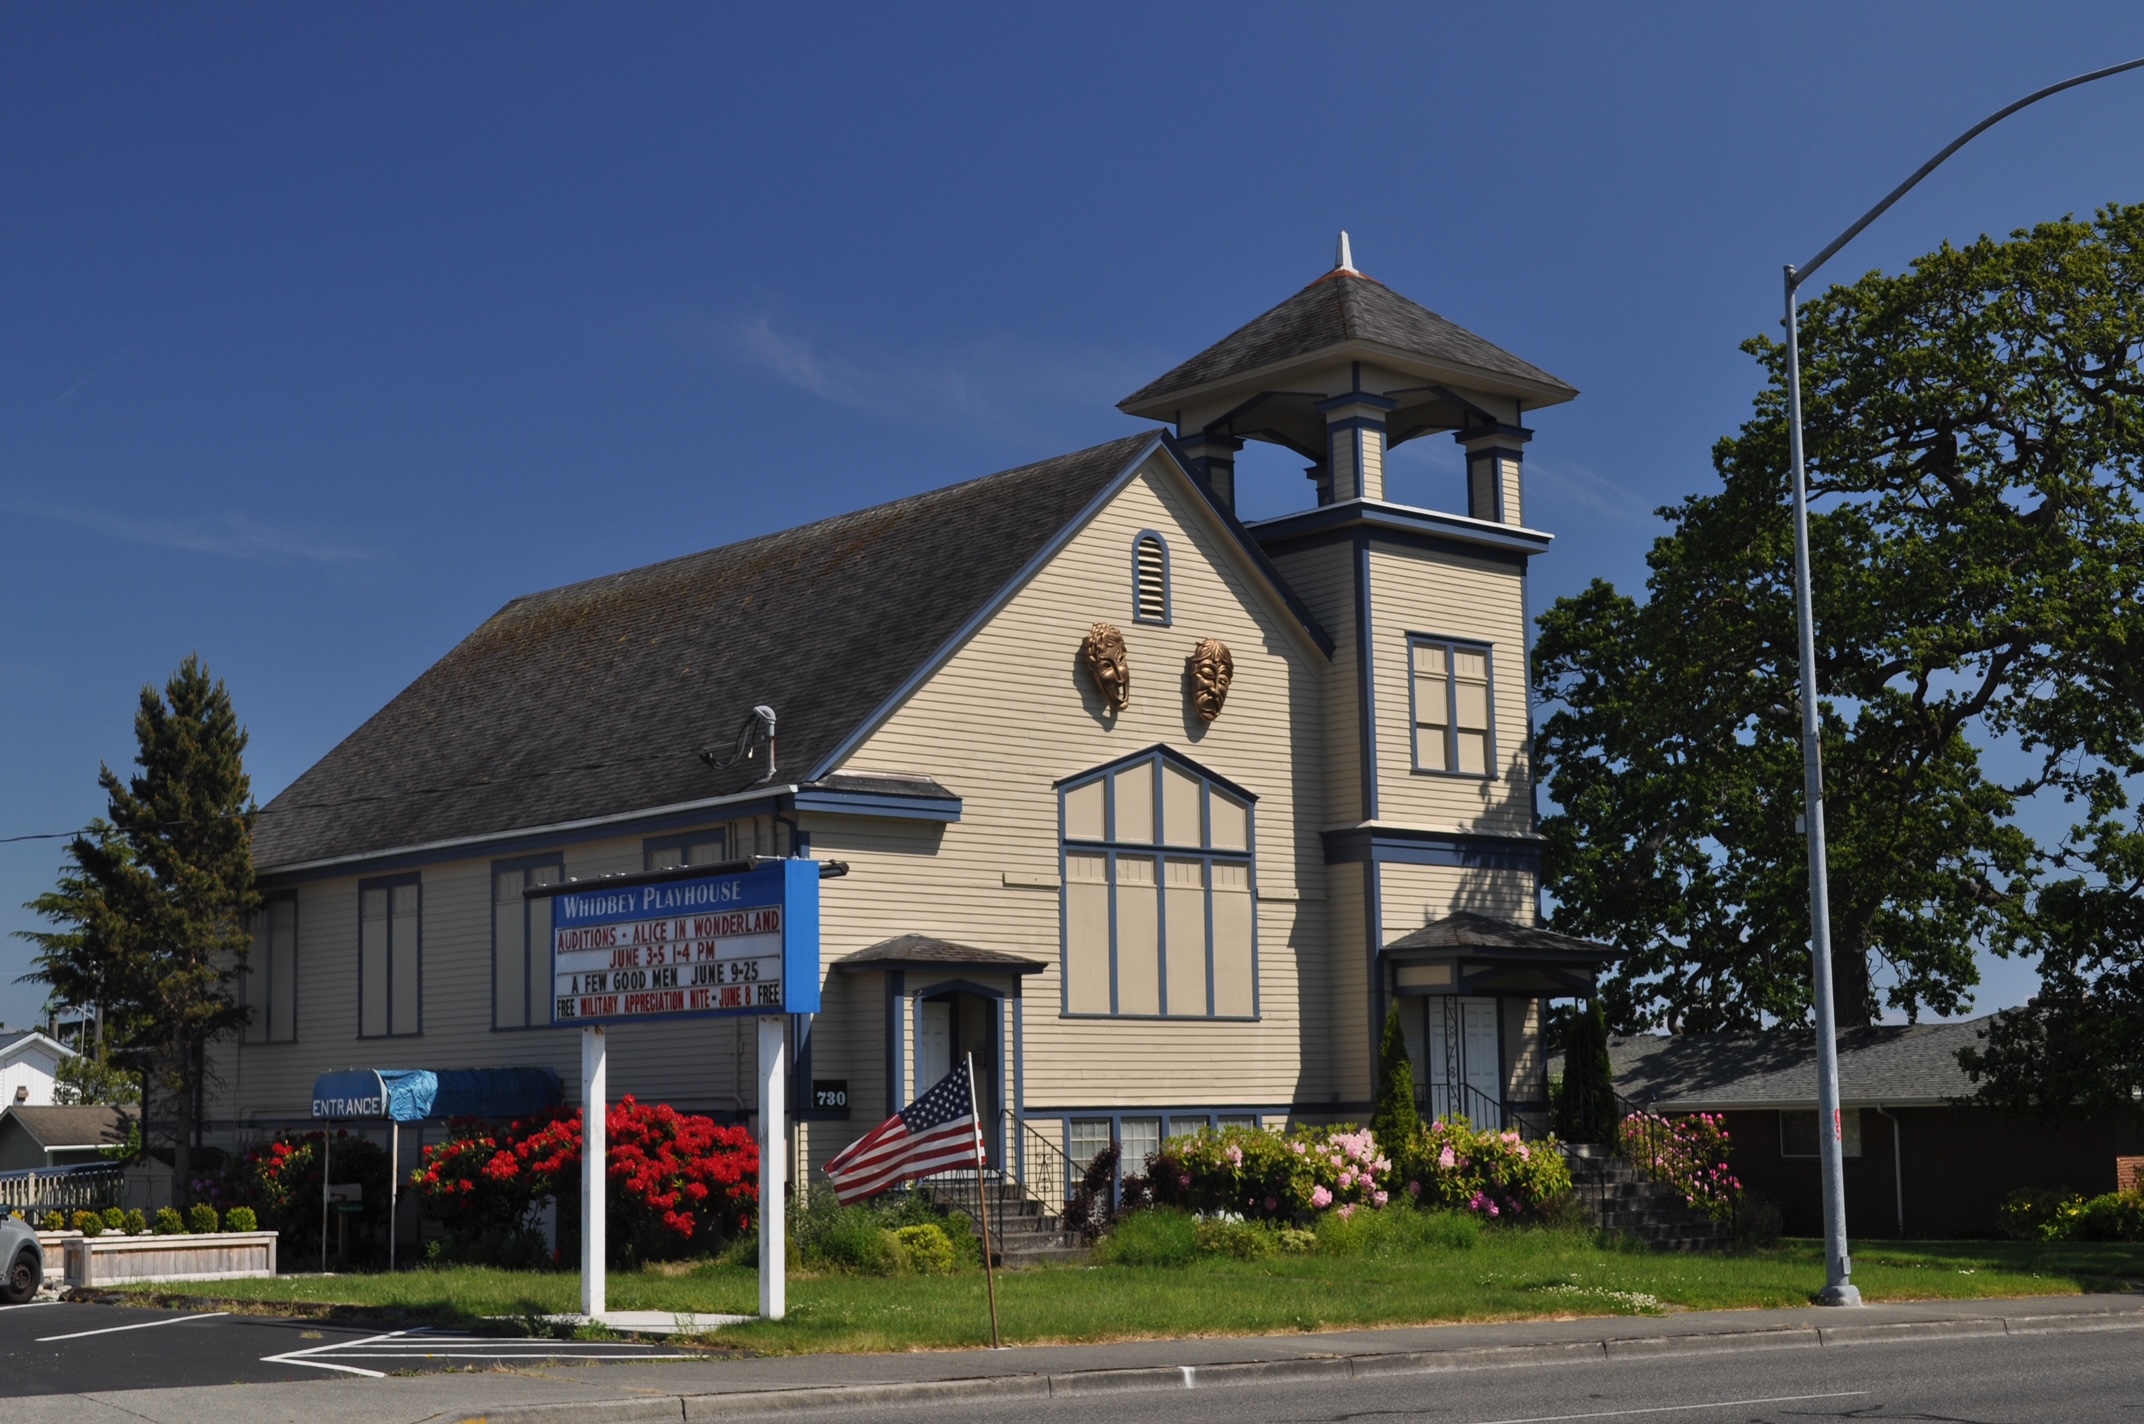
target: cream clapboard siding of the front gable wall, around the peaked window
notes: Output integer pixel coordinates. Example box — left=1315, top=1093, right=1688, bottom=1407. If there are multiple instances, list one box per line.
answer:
left=810, top=459, right=1327, bottom=1158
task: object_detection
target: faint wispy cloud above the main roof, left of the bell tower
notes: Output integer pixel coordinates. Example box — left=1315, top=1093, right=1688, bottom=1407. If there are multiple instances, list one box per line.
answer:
left=712, top=315, right=1162, bottom=433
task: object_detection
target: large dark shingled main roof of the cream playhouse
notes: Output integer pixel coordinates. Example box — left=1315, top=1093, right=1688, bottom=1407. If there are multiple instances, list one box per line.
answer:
left=253, top=431, right=1323, bottom=873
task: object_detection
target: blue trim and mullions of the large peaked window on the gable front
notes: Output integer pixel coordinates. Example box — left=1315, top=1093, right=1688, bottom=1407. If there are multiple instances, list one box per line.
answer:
left=1057, top=746, right=1265, bottom=1023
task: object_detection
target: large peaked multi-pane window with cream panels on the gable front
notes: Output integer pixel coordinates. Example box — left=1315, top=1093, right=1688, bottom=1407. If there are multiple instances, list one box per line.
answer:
left=1061, top=748, right=1259, bottom=1019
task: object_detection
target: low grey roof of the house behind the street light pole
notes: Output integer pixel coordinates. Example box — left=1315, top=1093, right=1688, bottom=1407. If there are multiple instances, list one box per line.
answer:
left=1608, top=1019, right=1987, bottom=1111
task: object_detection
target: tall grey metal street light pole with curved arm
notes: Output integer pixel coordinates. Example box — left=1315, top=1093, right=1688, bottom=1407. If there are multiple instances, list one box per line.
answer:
left=1786, top=60, right=2144, bottom=1306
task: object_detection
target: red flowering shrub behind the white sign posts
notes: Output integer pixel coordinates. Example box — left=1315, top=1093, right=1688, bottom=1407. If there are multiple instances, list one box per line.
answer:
left=414, top=1096, right=759, bottom=1261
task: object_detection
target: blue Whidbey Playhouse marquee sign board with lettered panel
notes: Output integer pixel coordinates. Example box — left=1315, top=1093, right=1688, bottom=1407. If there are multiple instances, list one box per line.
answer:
left=551, top=858, right=819, bottom=1025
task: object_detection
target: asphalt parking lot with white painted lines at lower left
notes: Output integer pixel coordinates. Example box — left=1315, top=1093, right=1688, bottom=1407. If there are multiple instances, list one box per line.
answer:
left=0, top=1304, right=694, bottom=1389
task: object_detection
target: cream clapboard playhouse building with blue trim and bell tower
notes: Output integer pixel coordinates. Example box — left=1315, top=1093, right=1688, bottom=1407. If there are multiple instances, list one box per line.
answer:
left=226, top=247, right=1597, bottom=1180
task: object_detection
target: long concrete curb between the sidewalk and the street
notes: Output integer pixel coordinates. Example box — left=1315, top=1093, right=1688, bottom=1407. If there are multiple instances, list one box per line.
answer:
left=442, top=1310, right=2144, bottom=1424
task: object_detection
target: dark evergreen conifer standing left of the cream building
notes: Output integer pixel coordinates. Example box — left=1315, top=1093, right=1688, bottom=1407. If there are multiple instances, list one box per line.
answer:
left=24, top=656, right=259, bottom=1201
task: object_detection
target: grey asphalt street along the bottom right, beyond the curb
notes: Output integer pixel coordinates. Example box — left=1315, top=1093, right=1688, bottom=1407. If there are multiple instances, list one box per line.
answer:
left=844, top=1330, right=2144, bottom=1424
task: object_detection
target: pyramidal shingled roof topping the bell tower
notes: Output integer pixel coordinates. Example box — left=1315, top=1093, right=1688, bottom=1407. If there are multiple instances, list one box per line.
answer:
left=1117, top=270, right=1578, bottom=412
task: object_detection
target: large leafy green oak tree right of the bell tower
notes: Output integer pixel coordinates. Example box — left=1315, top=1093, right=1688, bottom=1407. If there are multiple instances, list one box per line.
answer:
left=1535, top=208, right=2144, bottom=1068
